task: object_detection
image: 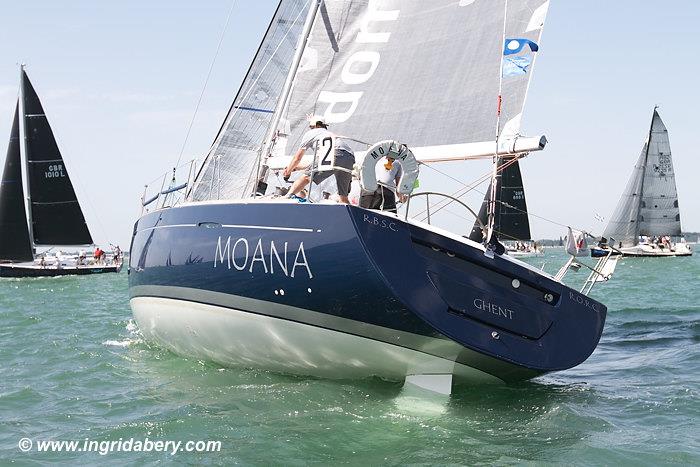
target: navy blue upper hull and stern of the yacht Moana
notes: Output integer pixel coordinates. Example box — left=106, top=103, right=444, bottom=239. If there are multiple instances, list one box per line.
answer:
left=129, top=203, right=606, bottom=381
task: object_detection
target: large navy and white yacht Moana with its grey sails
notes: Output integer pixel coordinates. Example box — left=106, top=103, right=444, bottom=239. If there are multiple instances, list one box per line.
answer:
left=129, top=0, right=607, bottom=393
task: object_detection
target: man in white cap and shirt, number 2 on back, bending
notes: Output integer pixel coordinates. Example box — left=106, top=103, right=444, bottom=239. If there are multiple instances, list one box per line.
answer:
left=284, top=116, right=355, bottom=204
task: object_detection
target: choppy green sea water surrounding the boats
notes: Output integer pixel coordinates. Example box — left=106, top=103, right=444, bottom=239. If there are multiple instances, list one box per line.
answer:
left=0, top=249, right=700, bottom=465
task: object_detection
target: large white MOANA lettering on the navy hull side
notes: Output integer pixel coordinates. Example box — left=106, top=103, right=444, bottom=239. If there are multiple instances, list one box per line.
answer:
left=214, top=235, right=314, bottom=279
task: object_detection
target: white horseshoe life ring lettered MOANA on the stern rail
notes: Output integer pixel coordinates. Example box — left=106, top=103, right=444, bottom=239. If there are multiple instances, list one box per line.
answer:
left=360, top=139, right=419, bottom=195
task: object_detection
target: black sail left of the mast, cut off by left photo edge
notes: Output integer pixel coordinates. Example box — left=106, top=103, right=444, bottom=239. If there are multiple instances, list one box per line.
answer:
left=0, top=102, right=34, bottom=261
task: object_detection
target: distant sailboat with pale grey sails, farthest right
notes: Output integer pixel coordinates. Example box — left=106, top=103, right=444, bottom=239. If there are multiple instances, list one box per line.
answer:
left=591, top=107, right=693, bottom=257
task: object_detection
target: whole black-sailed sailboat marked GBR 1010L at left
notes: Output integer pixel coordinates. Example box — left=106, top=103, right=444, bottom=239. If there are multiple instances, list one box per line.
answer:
left=0, top=65, right=121, bottom=277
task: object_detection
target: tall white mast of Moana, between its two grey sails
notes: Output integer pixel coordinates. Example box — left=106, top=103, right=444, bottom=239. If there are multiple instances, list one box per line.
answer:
left=253, top=0, right=323, bottom=192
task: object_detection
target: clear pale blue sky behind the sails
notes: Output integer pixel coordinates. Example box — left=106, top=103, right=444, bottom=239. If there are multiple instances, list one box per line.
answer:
left=0, top=0, right=700, bottom=249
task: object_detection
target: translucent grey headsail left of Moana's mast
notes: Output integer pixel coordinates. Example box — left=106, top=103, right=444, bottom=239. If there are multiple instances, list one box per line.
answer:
left=190, top=0, right=309, bottom=201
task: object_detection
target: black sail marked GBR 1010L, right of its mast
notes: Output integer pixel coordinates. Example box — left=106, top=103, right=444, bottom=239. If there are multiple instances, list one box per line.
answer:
left=22, top=70, right=93, bottom=245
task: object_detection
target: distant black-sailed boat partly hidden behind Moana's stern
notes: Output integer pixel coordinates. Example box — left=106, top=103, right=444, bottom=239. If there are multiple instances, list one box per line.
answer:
left=469, top=158, right=542, bottom=258
